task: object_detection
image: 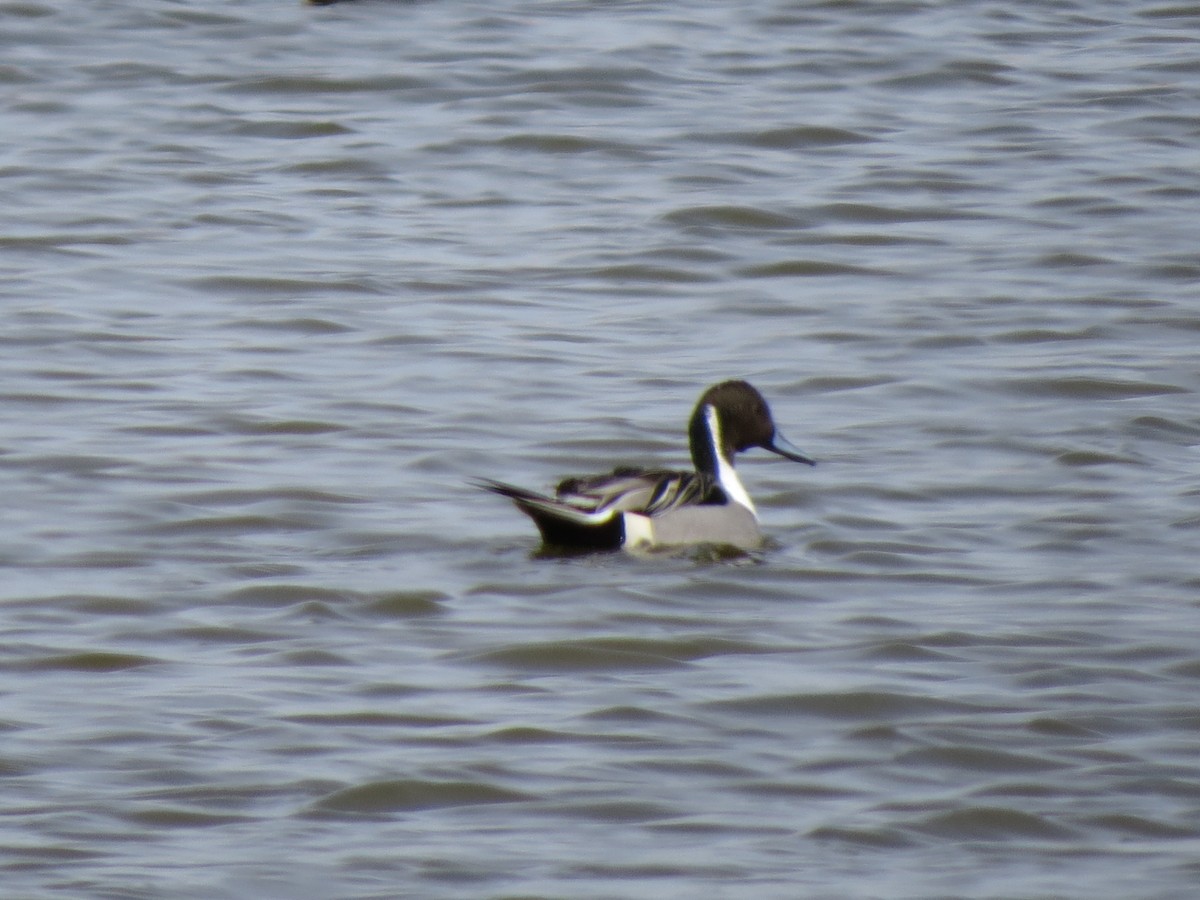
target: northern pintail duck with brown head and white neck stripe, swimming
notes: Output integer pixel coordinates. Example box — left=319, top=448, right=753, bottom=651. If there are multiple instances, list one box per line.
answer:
left=476, top=382, right=816, bottom=550
